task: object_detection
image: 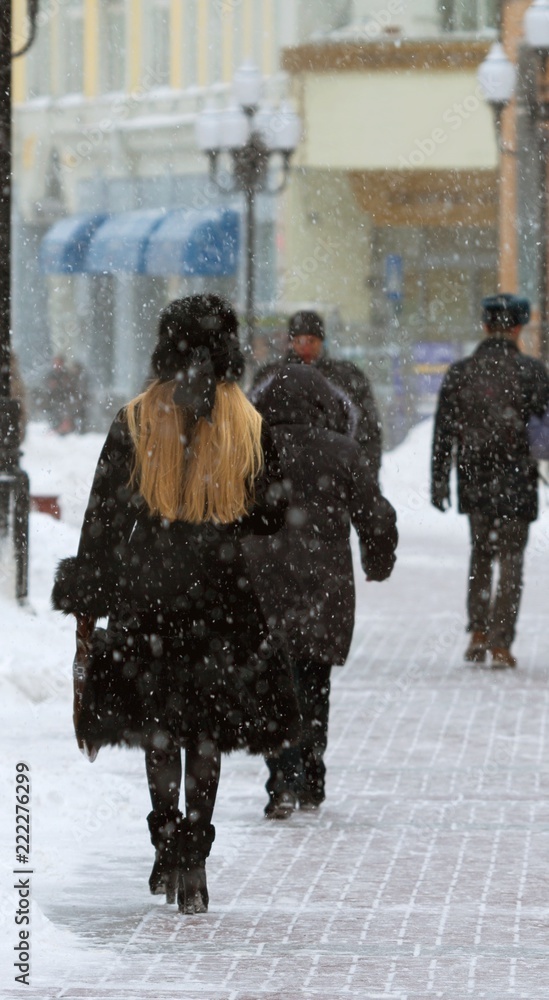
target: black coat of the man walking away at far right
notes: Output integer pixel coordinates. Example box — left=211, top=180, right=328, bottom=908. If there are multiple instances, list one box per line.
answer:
left=432, top=336, right=549, bottom=521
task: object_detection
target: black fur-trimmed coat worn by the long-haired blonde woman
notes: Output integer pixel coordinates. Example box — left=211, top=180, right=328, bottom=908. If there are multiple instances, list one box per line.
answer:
left=52, top=411, right=299, bottom=754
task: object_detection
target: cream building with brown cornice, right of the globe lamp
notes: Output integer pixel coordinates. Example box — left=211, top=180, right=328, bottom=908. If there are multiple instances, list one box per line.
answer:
left=283, top=0, right=498, bottom=426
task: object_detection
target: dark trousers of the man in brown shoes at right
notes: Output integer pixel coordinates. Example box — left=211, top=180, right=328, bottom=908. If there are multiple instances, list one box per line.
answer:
left=467, top=513, right=530, bottom=649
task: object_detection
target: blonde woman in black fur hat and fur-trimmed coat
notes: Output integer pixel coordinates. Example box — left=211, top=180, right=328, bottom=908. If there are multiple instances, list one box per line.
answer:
left=52, top=295, right=300, bottom=913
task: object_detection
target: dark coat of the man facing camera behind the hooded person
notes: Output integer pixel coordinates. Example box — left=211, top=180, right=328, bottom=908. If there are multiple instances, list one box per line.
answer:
left=253, top=347, right=382, bottom=479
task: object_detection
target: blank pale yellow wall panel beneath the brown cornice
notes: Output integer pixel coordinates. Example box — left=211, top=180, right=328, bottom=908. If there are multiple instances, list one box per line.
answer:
left=299, top=70, right=497, bottom=170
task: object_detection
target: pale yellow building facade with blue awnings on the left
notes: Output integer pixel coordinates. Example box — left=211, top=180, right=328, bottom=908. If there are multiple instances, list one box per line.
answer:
left=13, top=0, right=342, bottom=416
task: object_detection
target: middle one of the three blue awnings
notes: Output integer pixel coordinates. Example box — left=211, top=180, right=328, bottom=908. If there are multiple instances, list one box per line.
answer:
left=85, top=208, right=166, bottom=274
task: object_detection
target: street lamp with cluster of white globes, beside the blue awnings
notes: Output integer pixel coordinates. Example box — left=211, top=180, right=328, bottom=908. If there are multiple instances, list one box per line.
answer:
left=196, top=64, right=301, bottom=360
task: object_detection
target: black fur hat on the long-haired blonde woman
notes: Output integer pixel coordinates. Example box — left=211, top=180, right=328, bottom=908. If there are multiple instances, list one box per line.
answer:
left=151, top=295, right=244, bottom=382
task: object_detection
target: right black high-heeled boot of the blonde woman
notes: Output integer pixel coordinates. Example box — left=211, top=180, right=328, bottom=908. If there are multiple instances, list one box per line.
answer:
left=177, top=819, right=215, bottom=914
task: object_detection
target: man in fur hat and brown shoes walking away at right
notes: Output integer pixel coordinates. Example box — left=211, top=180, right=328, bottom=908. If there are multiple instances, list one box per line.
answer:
left=431, top=294, right=549, bottom=667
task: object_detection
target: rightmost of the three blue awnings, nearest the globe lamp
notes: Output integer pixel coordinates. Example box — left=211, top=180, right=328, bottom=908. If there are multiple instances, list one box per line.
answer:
left=145, top=209, right=239, bottom=277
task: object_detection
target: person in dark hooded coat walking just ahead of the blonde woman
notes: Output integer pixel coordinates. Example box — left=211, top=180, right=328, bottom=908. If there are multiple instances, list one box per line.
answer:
left=245, top=364, right=398, bottom=819
